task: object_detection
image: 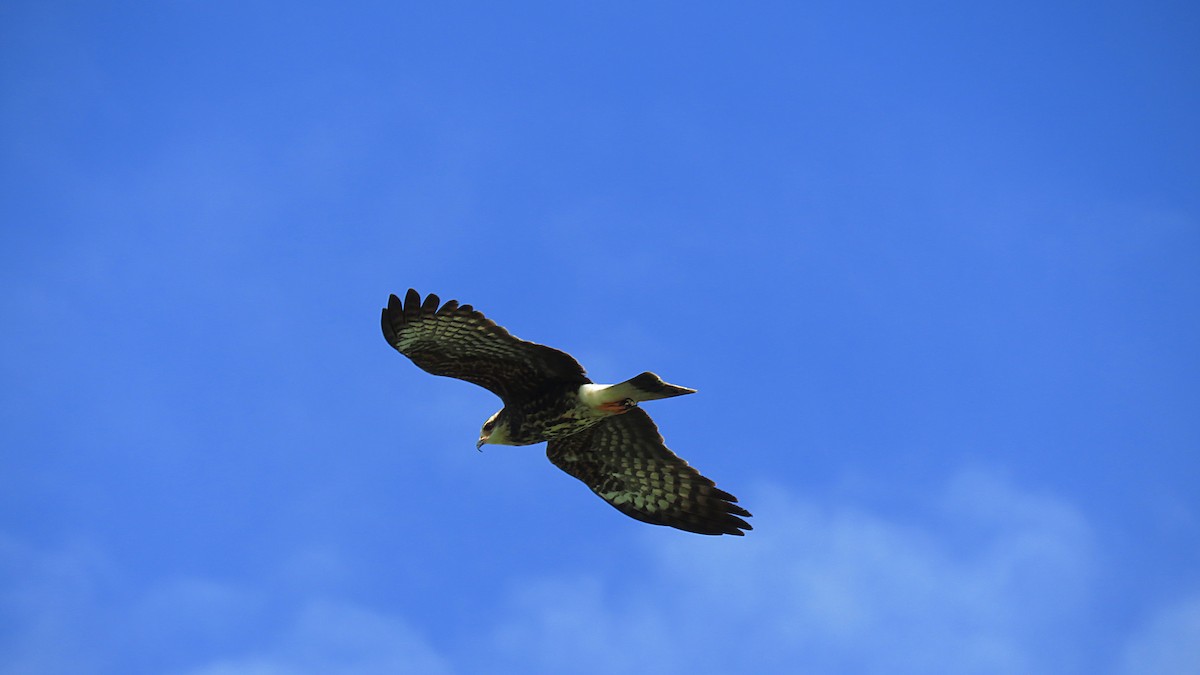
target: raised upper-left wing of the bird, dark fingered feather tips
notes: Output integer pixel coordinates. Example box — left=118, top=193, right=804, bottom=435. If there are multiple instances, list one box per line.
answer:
left=382, top=288, right=590, bottom=405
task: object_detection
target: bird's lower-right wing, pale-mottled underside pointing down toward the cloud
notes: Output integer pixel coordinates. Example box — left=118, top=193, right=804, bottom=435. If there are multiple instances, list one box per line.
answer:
left=546, top=408, right=754, bottom=536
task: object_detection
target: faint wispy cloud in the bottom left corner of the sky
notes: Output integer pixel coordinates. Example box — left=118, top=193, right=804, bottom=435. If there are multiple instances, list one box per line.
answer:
left=0, top=534, right=451, bottom=675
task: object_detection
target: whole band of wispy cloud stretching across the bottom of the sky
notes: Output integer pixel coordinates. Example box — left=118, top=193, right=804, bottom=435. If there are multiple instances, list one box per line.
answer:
left=0, top=471, right=1200, bottom=675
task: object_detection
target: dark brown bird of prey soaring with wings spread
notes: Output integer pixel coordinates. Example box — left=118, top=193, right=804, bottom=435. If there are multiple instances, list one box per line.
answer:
left=382, top=288, right=752, bottom=536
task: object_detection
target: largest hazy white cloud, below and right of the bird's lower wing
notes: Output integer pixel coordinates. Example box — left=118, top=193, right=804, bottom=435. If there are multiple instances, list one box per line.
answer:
left=484, top=474, right=1093, bottom=674
